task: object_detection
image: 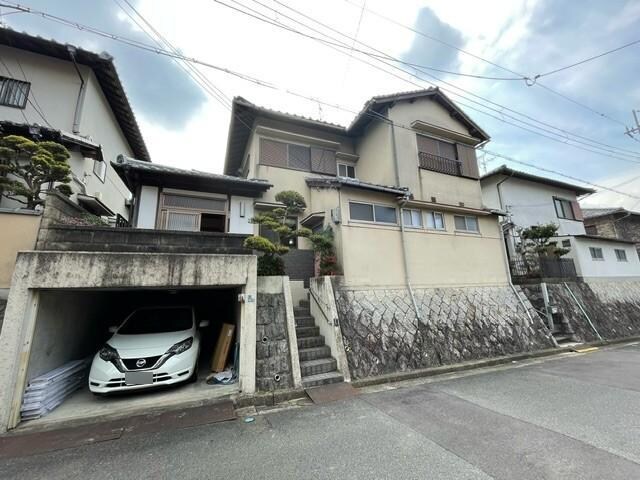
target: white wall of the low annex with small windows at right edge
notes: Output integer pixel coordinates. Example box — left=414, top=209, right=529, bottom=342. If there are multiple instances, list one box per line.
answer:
left=556, top=237, right=640, bottom=279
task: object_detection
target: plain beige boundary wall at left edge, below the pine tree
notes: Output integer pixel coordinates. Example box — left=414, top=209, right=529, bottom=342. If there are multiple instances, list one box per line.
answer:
left=0, top=212, right=41, bottom=289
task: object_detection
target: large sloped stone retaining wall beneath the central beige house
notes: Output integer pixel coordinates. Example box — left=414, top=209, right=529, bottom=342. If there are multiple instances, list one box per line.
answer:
left=335, top=286, right=554, bottom=379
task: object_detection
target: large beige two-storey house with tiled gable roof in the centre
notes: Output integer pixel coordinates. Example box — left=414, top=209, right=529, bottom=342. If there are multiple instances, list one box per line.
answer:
left=224, top=89, right=508, bottom=288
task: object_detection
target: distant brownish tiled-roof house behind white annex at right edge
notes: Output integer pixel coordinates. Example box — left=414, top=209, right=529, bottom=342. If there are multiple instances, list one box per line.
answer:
left=582, top=208, right=640, bottom=256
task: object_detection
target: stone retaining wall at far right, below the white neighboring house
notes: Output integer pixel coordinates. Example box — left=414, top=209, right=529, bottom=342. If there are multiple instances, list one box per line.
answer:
left=522, top=280, right=640, bottom=342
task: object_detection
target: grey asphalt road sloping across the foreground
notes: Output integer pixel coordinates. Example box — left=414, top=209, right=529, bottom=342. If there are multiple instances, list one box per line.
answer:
left=0, top=345, right=640, bottom=480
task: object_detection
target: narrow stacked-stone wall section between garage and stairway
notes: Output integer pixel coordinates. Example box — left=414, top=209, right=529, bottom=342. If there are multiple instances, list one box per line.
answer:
left=256, top=293, right=293, bottom=391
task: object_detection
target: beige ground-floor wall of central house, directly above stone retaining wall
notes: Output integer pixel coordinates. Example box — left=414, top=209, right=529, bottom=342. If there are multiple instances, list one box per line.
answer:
left=339, top=189, right=508, bottom=288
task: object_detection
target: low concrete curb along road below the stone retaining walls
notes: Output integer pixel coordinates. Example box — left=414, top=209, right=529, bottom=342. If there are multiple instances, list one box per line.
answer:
left=351, top=336, right=640, bottom=388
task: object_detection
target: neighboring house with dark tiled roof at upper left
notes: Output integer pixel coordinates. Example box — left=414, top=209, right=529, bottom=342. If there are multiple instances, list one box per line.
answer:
left=0, top=28, right=150, bottom=219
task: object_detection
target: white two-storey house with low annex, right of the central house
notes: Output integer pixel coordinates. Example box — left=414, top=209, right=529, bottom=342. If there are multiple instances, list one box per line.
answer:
left=480, top=165, right=640, bottom=279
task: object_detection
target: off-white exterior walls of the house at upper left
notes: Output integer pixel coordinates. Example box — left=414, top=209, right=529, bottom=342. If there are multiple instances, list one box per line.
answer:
left=0, top=46, right=133, bottom=218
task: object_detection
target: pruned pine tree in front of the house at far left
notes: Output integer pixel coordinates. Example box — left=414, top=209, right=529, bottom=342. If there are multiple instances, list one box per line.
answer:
left=0, top=135, right=71, bottom=209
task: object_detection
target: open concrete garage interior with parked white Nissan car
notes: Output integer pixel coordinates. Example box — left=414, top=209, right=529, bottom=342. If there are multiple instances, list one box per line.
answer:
left=18, top=287, right=241, bottom=424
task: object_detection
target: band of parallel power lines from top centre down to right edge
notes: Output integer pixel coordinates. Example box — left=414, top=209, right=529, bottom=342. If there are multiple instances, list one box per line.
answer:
left=214, top=0, right=640, bottom=160
